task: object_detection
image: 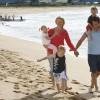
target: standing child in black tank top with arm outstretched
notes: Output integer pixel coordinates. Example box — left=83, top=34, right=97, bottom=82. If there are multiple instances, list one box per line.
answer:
left=37, top=45, right=67, bottom=93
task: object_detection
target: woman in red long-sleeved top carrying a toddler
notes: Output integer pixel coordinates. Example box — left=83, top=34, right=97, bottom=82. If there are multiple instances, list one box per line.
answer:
left=47, top=17, right=78, bottom=89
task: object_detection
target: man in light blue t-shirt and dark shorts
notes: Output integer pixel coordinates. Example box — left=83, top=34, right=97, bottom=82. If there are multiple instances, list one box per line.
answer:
left=76, top=16, right=100, bottom=92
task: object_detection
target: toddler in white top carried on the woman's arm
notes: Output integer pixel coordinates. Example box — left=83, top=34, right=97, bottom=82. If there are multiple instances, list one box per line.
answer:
left=41, top=25, right=57, bottom=53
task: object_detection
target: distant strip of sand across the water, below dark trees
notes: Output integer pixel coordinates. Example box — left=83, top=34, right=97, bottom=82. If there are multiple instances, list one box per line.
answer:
left=0, top=6, right=90, bottom=16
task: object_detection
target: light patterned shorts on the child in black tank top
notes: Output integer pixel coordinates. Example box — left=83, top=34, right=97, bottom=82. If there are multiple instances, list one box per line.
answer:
left=53, top=71, right=68, bottom=84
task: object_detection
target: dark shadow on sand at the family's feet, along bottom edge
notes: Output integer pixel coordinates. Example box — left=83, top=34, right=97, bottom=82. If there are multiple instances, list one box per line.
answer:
left=16, top=87, right=100, bottom=100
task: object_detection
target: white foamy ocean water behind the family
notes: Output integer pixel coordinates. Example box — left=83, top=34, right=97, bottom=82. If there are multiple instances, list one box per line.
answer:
left=0, top=10, right=95, bottom=58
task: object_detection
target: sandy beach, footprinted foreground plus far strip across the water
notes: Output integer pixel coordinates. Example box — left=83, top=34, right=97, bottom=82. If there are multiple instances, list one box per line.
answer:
left=0, top=7, right=100, bottom=100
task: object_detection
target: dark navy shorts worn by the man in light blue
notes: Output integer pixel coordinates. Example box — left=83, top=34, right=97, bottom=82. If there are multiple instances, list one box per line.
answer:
left=88, top=54, right=100, bottom=73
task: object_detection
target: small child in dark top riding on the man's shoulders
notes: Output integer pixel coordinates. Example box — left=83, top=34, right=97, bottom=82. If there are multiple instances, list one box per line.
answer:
left=86, top=6, right=98, bottom=41
